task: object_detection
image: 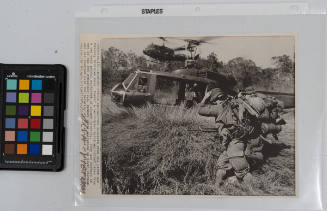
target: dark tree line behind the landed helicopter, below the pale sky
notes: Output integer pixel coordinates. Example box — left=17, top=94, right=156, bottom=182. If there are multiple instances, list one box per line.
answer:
left=101, top=47, right=295, bottom=93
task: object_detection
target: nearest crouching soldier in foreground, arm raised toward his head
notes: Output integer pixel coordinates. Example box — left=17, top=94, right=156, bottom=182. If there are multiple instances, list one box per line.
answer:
left=199, top=88, right=251, bottom=185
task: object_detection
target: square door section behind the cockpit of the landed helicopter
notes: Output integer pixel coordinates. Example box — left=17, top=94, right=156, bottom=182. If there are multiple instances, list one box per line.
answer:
left=153, top=76, right=180, bottom=105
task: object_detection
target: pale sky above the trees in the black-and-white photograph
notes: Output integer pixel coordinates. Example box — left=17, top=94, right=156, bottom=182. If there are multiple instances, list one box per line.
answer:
left=101, top=35, right=295, bottom=68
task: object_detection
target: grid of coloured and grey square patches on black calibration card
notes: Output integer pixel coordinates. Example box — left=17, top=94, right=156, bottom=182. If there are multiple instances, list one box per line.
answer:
left=4, top=78, right=55, bottom=156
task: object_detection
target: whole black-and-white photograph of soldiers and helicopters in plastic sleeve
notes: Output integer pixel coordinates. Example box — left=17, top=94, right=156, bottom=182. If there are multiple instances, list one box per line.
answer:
left=100, top=34, right=297, bottom=196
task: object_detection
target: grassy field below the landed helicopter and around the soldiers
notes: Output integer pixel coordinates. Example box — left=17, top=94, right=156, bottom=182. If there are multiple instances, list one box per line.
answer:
left=102, top=95, right=295, bottom=195
